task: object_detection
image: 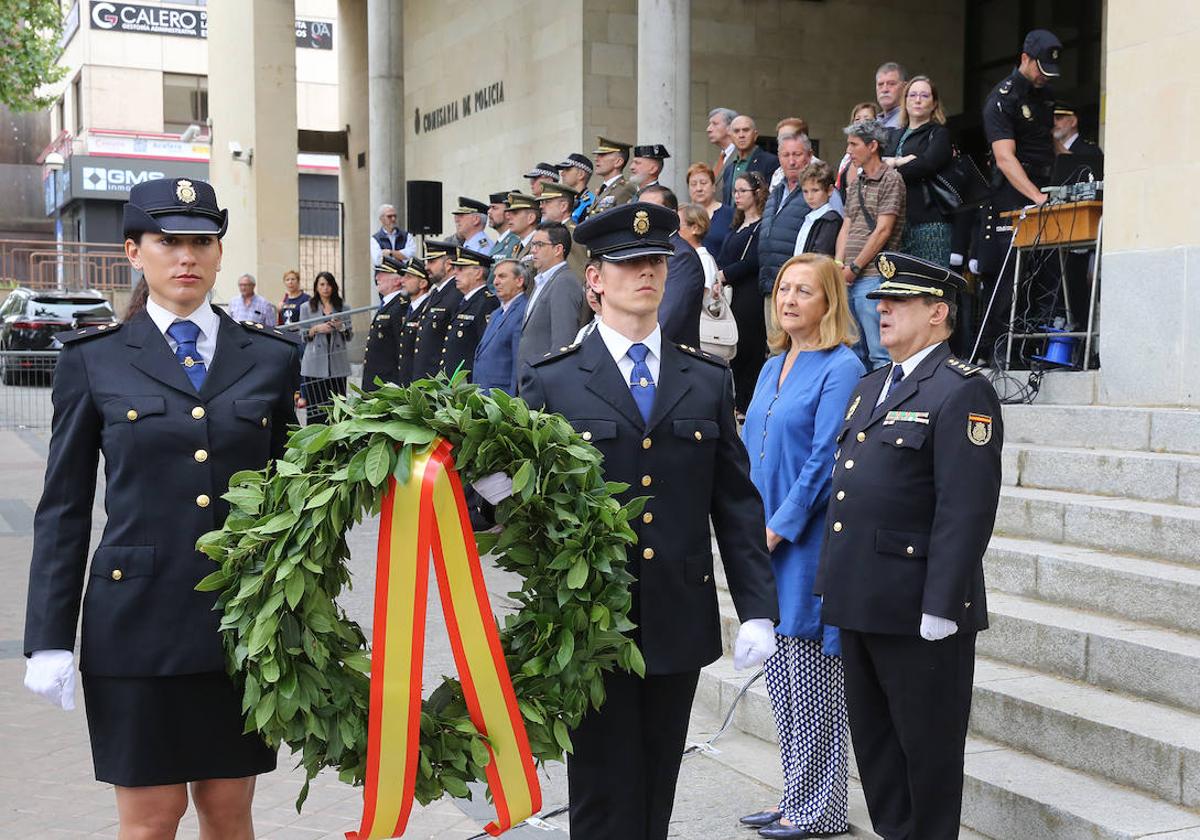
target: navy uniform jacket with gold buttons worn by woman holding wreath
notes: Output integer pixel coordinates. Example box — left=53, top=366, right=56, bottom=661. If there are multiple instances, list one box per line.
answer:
left=25, top=312, right=300, bottom=677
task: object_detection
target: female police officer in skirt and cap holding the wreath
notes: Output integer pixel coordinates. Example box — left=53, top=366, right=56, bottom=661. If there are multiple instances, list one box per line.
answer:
left=25, top=179, right=299, bottom=840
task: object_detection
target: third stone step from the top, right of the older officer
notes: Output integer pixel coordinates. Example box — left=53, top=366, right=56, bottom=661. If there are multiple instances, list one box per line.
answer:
left=995, top=487, right=1200, bottom=566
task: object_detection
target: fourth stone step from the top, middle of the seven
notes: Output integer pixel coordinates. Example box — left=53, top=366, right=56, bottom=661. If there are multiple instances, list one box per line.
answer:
left=984, top=536, right=1200, bottom=634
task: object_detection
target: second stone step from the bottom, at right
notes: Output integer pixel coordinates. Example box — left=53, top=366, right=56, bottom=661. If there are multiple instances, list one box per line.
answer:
left=971, top=659, right=1200, bottom=809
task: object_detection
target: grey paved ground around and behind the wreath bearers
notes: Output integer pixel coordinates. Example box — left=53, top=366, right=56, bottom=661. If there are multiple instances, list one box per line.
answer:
left=0, top=429, right=778, bottom=840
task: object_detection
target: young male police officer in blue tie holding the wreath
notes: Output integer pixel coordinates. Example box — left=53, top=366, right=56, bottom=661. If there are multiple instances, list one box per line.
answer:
left=520, top=203, right=779, bottom=840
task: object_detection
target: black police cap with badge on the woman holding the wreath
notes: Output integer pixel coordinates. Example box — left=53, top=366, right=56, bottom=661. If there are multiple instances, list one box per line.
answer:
left=122, top=178, right=229, bottom=239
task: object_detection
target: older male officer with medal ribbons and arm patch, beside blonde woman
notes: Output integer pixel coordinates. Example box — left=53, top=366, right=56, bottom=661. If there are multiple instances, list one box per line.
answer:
left=815, top=252, right=1003, bottom=840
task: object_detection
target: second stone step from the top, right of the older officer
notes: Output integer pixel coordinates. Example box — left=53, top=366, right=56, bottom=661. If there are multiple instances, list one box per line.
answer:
left=1003, top=443, right=1200, bottom=505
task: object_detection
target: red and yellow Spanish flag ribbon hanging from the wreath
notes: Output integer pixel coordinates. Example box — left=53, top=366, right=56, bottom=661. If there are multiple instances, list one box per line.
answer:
left=346, top=440, right=541, bottom=840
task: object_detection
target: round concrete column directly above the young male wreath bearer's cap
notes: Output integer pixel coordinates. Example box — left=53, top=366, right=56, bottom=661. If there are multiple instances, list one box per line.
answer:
left=635, top=0, right=691, bottom=197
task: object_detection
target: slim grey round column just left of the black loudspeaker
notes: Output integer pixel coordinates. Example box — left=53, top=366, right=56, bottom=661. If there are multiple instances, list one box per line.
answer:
left=366, top=0, right=407, bottom=230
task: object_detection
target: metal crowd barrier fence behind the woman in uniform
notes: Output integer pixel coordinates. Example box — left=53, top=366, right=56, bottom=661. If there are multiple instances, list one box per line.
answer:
left=0, top=306, right=376, bottom=431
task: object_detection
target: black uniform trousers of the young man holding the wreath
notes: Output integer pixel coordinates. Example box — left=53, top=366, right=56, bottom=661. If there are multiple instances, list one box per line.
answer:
left=566, top=671, right=700, bottom=840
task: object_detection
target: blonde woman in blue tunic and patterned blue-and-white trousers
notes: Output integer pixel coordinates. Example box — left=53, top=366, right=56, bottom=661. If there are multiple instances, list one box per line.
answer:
left=742, top=253, right=870, bottom=838
